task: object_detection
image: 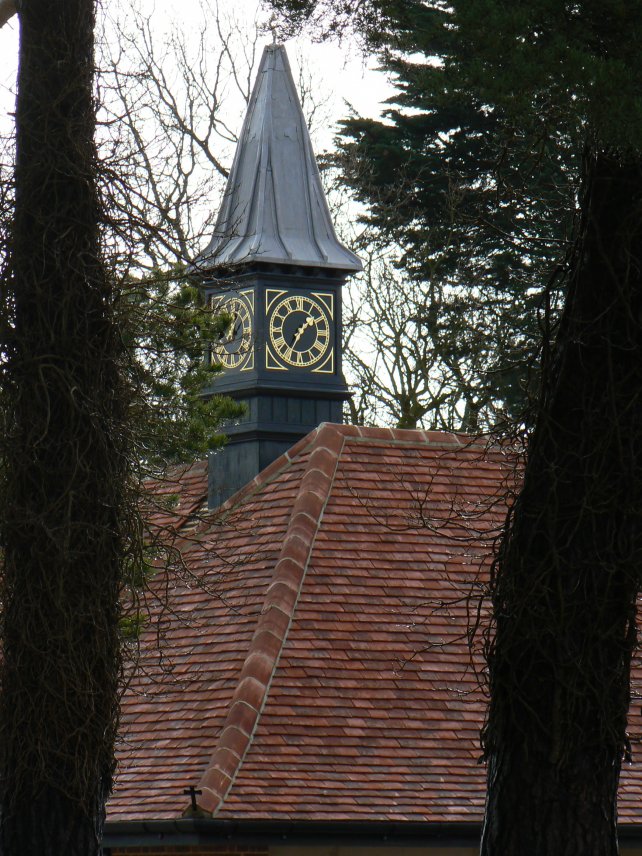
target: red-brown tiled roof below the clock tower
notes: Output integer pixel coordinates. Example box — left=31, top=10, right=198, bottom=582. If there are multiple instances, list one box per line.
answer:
left=109, top=425, right=642, bottom=822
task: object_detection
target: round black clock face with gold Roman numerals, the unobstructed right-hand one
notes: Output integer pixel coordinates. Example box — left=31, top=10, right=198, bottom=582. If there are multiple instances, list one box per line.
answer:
left=269, top=294, right=330, bottom=368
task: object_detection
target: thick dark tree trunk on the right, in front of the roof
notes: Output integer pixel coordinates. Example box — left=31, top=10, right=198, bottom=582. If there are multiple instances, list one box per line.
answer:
left=481, top=151, right=642, bottom=856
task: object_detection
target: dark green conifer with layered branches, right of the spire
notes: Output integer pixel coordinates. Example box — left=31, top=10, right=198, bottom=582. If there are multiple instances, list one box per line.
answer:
left=337, top=0, right=579, bottom=430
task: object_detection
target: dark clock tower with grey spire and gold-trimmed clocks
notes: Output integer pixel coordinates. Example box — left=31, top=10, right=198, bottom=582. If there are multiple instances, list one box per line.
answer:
left=195, top=44, right=361, bottom=508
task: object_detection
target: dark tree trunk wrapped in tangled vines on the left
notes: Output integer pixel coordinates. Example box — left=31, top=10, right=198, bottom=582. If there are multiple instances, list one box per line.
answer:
left=0, top=0, right=127, bottom=856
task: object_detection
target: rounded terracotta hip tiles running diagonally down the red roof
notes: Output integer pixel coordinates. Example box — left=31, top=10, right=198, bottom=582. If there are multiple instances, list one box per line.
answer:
left=198, top=424, right=345, bottom=815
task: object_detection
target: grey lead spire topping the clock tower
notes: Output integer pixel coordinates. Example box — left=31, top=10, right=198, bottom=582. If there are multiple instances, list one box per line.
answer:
left=196, top=44, right=362, bottom=273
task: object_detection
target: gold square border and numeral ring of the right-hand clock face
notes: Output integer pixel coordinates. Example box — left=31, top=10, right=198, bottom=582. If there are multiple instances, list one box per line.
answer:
left=266, top=290, right=334, bottom=371
